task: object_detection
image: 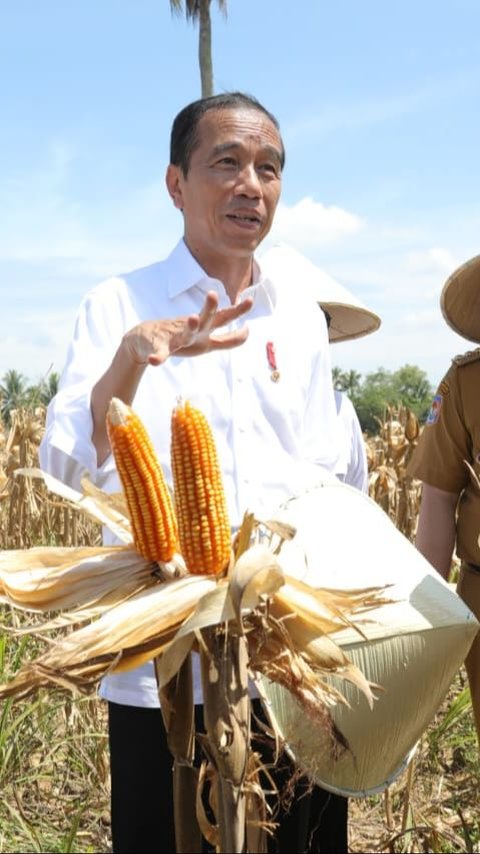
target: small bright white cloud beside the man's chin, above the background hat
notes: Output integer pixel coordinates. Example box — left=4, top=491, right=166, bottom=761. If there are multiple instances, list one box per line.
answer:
left=270, top=196, right=364, bottom=248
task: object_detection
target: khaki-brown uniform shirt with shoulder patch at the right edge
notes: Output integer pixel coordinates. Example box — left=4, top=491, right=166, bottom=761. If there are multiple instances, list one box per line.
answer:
left=408, top=348, right=480, bottom=565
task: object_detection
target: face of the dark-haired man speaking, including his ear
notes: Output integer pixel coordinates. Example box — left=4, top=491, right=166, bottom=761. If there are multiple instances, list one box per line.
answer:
left=167, top=108, right=282, bottom=261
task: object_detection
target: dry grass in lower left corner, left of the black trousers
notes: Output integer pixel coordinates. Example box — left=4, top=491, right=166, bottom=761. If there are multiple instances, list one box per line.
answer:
left=0, top=694, right=110, bottom=852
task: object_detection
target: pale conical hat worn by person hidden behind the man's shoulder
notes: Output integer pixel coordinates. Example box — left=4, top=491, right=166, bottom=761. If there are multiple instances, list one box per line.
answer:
left=260, top=244, right=381, bottom=342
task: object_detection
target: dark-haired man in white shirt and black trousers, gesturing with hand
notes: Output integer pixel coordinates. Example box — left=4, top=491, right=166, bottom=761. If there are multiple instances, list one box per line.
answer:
left=40, top=93, right=338, bottom=854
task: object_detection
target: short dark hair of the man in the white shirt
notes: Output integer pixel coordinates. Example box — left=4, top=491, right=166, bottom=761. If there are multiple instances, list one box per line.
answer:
left=170, top=92, right=285, bottom=176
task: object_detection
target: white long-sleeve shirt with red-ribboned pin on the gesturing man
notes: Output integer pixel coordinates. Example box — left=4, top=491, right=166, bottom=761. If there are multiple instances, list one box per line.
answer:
left=40, top=240, right=339, bottom=706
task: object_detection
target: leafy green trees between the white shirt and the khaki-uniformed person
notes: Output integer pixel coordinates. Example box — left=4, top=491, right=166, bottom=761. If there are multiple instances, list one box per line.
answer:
left=333, top=365, right=433, bottom=435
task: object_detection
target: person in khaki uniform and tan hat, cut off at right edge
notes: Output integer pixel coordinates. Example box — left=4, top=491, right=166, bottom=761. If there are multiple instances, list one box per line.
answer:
left=408, top=255, right=480, bottom=742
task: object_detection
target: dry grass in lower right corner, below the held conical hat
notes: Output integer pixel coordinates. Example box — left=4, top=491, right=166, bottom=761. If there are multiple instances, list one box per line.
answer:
left=350, top=669, right=480, bottom=852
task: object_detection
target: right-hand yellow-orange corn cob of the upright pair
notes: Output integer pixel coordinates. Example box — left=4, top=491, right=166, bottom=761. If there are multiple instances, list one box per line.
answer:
left=172, top=401, right=231, bottom=575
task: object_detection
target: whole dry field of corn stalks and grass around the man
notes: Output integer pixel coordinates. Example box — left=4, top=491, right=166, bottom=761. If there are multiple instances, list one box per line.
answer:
left=0, top=408, right=480, bottom=852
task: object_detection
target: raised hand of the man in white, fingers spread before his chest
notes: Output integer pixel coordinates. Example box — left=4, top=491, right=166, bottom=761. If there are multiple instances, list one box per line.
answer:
left=122, top=291, right=253, bottom=365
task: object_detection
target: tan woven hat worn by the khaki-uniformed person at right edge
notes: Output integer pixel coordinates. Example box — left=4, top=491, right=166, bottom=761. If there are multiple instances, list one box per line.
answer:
left=440, top=255, right=480, bottom=344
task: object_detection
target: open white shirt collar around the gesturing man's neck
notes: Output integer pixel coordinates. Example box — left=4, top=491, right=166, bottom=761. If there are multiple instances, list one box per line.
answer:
left=168, top=238, right=277, bottom=308
